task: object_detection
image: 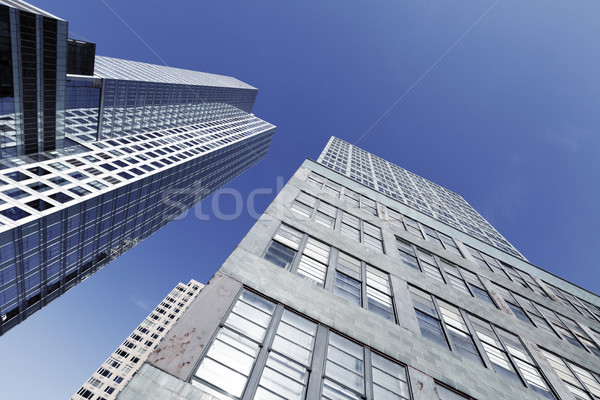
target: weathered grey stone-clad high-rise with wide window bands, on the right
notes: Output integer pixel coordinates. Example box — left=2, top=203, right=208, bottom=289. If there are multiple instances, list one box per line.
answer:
left=116, top=138, right=600, bottom=400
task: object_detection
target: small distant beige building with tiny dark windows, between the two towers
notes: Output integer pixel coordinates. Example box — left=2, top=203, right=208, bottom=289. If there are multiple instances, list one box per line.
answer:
left=71, top=279, right=204, bottom=400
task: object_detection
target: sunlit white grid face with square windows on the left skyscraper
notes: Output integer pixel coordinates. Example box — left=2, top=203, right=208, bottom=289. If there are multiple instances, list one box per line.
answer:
left=0, top=118, right=268, bottom=227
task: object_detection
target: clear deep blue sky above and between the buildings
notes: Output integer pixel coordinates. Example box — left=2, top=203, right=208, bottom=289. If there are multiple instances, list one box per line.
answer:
left=0, top=0, right=600, bottom=399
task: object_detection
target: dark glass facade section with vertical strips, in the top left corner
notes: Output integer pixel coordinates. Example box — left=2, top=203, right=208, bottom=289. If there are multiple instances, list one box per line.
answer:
left=0, top=2, right=67, bottom=159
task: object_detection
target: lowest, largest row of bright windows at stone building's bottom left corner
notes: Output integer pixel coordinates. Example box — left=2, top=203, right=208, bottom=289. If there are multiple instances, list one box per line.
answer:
left=192, top=290, right=466, bottom=400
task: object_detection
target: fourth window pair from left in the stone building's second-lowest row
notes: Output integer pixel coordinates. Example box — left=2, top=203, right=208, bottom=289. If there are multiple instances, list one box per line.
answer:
left=469, top=315, right=556, bottom=399
